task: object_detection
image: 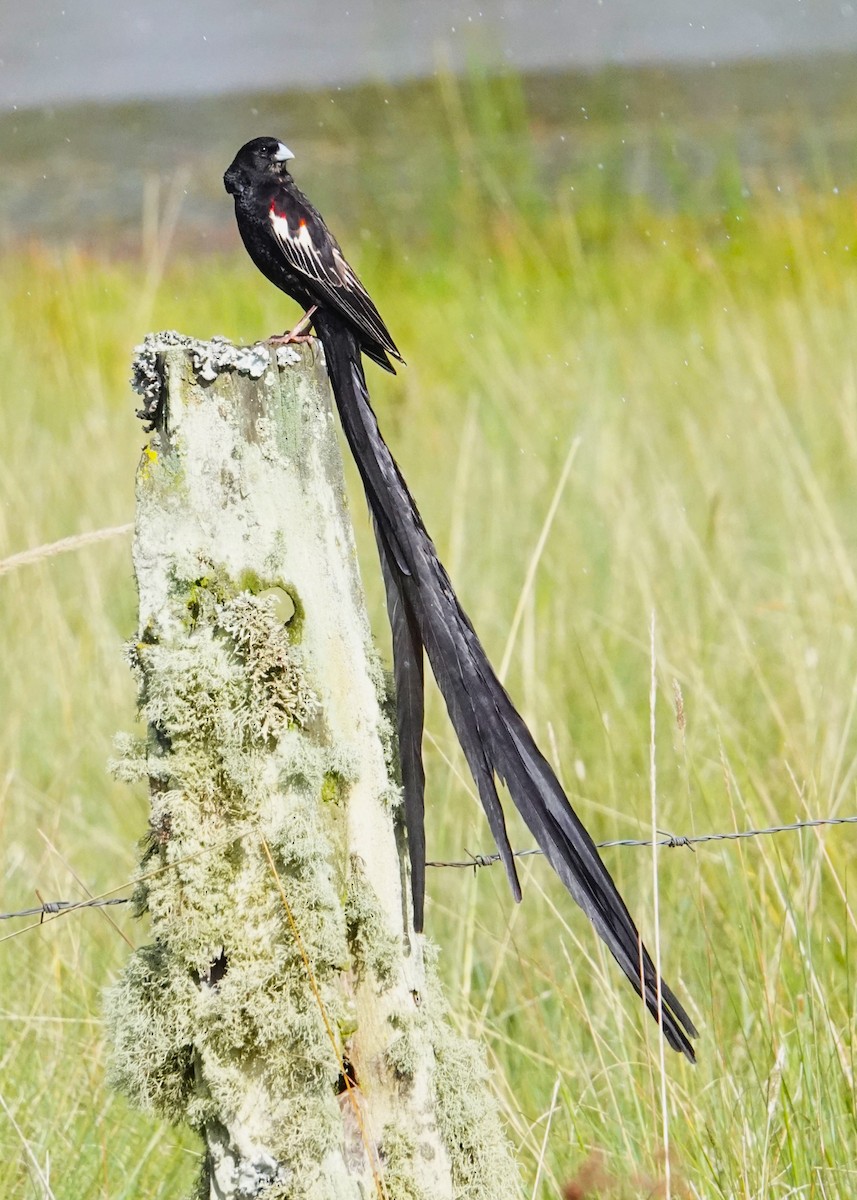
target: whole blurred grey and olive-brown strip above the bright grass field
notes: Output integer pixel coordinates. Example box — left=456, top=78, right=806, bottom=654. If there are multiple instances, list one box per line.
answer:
left=0, top=0, right=857, bottom=248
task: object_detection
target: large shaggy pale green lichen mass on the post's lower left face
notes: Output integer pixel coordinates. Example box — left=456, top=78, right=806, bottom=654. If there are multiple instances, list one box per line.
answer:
left=107, top=570, right=354, bottom=1196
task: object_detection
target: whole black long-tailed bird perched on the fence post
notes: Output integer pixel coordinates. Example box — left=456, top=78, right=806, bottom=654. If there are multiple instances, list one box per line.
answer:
left=223, top=138, right=697, bottom=1062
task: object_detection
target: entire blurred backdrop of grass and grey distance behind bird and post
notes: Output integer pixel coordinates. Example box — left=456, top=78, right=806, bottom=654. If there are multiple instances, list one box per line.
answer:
left=0, top=0, right=857, bottom=1200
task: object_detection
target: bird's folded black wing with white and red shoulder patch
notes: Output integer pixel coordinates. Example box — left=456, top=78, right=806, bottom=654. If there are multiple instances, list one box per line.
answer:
left=268, top=200, right=402, bottom=360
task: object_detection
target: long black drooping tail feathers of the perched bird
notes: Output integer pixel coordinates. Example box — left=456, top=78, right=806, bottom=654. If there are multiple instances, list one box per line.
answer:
left=316, top=311, right=696, bottom=1062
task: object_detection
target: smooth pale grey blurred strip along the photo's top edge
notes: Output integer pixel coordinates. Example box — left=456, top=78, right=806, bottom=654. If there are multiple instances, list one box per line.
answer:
left=0, top=0, right=857, bottom=109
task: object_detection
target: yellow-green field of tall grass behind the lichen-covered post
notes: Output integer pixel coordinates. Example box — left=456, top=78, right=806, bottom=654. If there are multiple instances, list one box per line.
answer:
left=0, top=108, right=857, bottom=1200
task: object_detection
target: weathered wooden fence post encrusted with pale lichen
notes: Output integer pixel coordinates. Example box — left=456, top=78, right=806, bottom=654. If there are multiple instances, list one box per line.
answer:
left=108, top=334, right=519, bottom=1200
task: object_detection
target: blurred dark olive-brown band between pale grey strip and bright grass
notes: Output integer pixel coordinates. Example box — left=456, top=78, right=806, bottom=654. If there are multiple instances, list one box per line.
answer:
left=0, top=54, right=857, bottom=253
